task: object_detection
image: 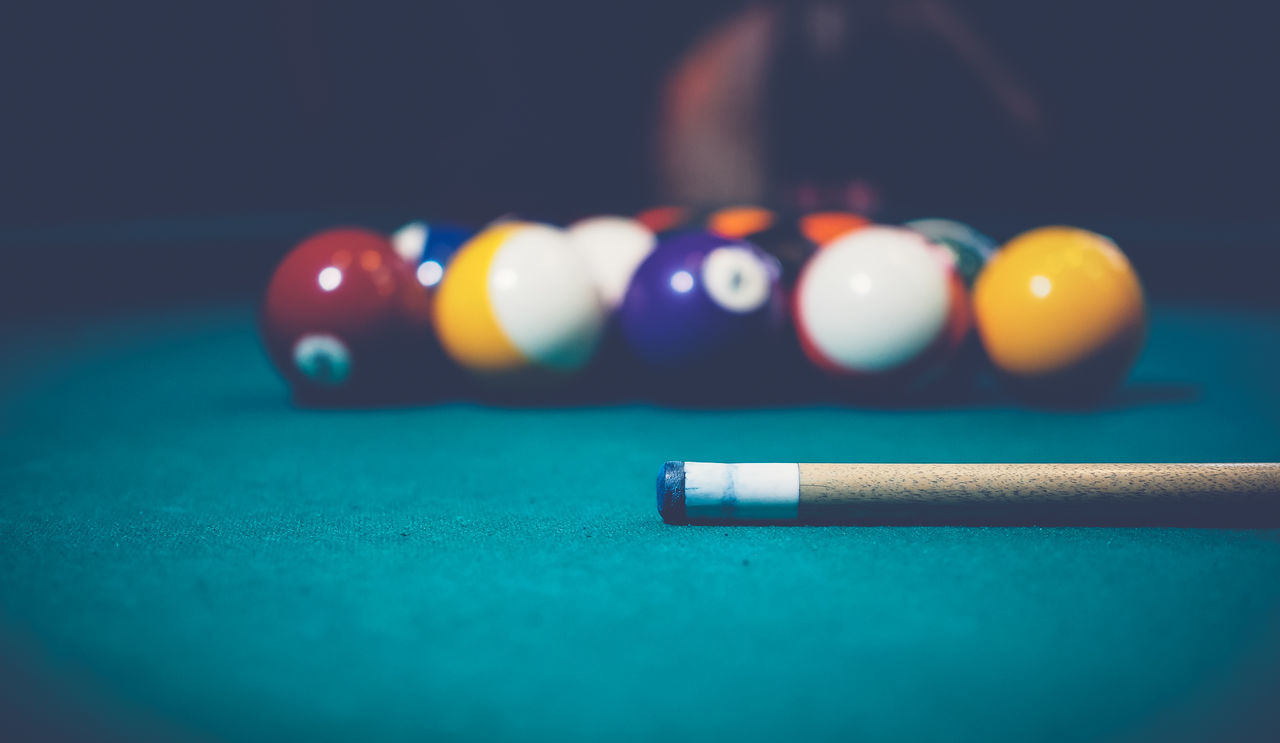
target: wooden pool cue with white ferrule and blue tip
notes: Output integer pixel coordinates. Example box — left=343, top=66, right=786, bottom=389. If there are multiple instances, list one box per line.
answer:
left=658, top=461, right=1280, bottom=528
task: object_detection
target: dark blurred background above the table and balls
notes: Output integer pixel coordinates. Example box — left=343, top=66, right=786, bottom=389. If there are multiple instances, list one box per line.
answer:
left=0, top=0, right=1280, bottom=319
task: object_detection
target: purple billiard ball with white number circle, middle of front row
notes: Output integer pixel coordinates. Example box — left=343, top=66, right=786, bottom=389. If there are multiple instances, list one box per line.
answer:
left=618, top=231, right=786, bottom=369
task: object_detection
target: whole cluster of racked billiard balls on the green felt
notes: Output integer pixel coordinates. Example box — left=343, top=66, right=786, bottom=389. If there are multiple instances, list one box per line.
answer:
left=261, top=206, right=1146, bottom=401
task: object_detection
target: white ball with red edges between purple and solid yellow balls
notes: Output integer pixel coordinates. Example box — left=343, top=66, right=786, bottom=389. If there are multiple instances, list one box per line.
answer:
left=794, top=225, right=969, bottom=384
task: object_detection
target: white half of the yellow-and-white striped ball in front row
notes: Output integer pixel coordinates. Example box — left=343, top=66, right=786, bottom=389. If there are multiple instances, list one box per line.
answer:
left=486, top=224, right=605, bottom=372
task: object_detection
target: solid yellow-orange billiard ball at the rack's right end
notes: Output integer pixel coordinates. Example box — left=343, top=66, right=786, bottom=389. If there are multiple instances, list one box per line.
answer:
left=974, top=227, right=1146, bottom=400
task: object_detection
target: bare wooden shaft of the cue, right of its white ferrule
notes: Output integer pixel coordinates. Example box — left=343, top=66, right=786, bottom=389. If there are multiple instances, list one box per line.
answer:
left=797, top=462, right=1280, bottom=525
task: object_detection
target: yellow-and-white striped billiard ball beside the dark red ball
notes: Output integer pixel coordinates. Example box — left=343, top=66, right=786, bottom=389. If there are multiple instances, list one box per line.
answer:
left=434, top=220, right=605, bottom=379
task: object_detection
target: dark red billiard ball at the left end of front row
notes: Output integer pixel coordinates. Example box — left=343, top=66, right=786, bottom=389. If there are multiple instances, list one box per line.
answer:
left=260, top=228, right=434, bottom=398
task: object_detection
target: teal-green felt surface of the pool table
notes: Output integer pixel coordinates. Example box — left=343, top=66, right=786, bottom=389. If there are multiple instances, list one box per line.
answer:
left=0, top=307, right=1280, bottom=740
